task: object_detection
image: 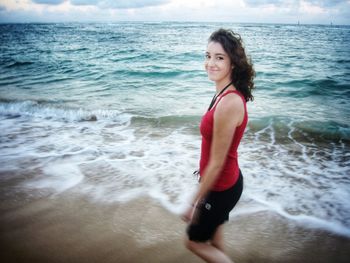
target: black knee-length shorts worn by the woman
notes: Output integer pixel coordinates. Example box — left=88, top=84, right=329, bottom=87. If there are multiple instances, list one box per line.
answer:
left=187, top=172, right=243, bottom=242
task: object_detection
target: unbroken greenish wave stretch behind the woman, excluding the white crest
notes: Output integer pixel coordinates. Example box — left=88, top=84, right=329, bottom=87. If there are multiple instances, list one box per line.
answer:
left=131, top=115, right=350, bottom=144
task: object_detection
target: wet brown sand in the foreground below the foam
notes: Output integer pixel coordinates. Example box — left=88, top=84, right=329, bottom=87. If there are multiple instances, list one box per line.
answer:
left=0, top=192, right=350, bottom=263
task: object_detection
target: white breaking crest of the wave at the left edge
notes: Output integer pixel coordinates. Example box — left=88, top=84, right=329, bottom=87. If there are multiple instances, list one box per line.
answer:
left=0, top=99, right=131, bottom=124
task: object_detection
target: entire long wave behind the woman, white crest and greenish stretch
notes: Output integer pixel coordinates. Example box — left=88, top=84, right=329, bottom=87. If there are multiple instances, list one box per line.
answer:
left=0, top=98, right=350, bottom=144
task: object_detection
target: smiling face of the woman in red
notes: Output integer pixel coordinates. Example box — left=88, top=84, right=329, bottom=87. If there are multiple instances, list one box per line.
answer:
left=204, top=41, right=232, bottom=83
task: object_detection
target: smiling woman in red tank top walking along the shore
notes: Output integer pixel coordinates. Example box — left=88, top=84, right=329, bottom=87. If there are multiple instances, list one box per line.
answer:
left=182, top=29, right=255, bottom=263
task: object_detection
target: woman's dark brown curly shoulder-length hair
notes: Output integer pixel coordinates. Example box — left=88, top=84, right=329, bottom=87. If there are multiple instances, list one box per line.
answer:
left=208, top=28, right=255, bottom=101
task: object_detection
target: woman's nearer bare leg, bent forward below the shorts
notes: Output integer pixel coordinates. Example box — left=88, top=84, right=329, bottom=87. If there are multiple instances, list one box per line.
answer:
left=186, top=239, right=232, bottom=263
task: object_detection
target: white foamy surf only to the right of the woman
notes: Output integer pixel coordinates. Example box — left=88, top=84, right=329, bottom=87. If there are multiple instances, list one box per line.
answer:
left=240, top=117, right=350, bottom=236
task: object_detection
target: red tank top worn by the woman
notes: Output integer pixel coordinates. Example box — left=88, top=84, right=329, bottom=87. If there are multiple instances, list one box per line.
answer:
left=199, top=90, right=248, bottom=191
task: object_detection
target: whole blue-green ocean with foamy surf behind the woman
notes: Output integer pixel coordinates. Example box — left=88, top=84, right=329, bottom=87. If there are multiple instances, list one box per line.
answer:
left=0, top=22, right=350, bottom=237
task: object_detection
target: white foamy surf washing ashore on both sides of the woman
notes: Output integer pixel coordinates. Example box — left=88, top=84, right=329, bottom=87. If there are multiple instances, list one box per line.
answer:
left=1, top=109, right=350, bottom=239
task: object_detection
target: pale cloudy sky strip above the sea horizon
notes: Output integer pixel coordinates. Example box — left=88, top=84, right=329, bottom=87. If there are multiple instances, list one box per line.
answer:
left=0, top=0, right=350, bottom=25
